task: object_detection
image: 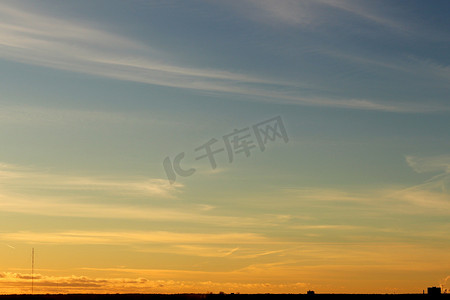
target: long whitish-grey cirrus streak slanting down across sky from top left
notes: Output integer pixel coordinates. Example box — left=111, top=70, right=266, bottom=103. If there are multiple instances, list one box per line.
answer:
left=0, top=1, right=438, bottom=112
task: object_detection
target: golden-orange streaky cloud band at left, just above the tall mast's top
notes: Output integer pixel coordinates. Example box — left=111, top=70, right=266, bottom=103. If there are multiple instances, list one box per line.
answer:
left=0, top=230, right=294, bottom=259
